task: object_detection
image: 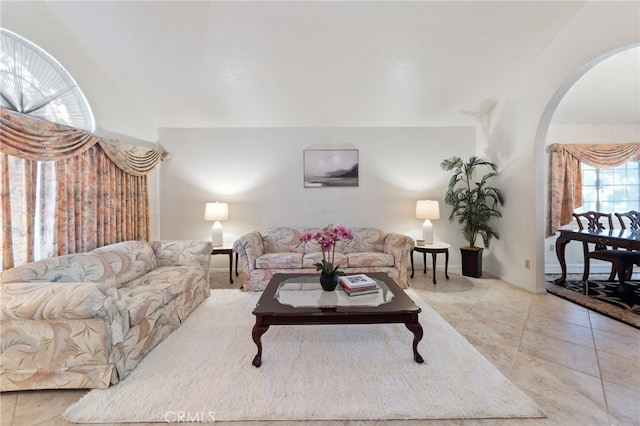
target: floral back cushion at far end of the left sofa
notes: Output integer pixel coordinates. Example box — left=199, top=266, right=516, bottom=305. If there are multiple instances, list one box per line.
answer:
left=91, top=241, right=158, bottom=286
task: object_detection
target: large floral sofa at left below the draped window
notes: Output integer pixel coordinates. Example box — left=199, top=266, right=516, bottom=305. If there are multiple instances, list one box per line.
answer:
left=0, top=241, right=212, bottom=391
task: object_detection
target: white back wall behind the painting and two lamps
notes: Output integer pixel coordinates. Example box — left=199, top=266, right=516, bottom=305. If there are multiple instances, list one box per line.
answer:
left=159, top=127, right=476, bottom=271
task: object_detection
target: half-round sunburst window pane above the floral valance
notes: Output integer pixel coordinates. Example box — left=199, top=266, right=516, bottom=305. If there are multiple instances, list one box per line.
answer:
left=0, top=28, right=96, bottom=133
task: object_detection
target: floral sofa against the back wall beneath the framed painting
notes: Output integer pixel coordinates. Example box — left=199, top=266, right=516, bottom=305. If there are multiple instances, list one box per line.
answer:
left=233, top=227, right=415, bottom=291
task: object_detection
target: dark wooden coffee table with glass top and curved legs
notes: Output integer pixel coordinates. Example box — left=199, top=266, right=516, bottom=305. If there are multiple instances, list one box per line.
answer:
left=251, top=272, right=424, bottom=367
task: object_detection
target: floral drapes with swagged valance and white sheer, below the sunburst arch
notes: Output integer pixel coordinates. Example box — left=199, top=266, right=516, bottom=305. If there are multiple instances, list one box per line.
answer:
left=0, top=108, right=168, bottom=269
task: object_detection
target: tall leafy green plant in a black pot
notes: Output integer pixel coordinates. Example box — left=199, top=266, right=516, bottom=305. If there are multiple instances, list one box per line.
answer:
left=440, top=156, right=504, bottom=278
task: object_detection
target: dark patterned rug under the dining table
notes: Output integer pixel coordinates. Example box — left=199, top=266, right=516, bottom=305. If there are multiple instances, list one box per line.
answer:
left=546, top=277, right=640, bottom=329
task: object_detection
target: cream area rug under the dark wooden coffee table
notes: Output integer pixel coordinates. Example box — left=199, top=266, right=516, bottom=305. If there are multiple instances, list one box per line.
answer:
left=64, top=290, right=544, bottom=423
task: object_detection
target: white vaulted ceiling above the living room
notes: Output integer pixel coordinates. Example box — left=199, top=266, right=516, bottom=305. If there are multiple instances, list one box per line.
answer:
left=5, top=1, right=638, bottom=127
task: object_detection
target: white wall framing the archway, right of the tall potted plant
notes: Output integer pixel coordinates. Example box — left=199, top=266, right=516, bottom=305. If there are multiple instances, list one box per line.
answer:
left=487, top=2, right=640, bottom=293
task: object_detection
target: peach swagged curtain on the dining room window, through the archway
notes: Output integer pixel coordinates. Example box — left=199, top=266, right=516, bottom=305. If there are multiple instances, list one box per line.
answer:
left=547, top=143, right=640, bottom=237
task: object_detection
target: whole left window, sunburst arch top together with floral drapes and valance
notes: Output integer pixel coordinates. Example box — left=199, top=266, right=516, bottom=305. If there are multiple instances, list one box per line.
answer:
left=0, top=30, right=162, bottom=269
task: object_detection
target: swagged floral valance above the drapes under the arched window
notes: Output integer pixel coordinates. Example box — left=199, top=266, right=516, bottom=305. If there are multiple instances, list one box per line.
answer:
left=0, top=108, right=168, bottom=176
